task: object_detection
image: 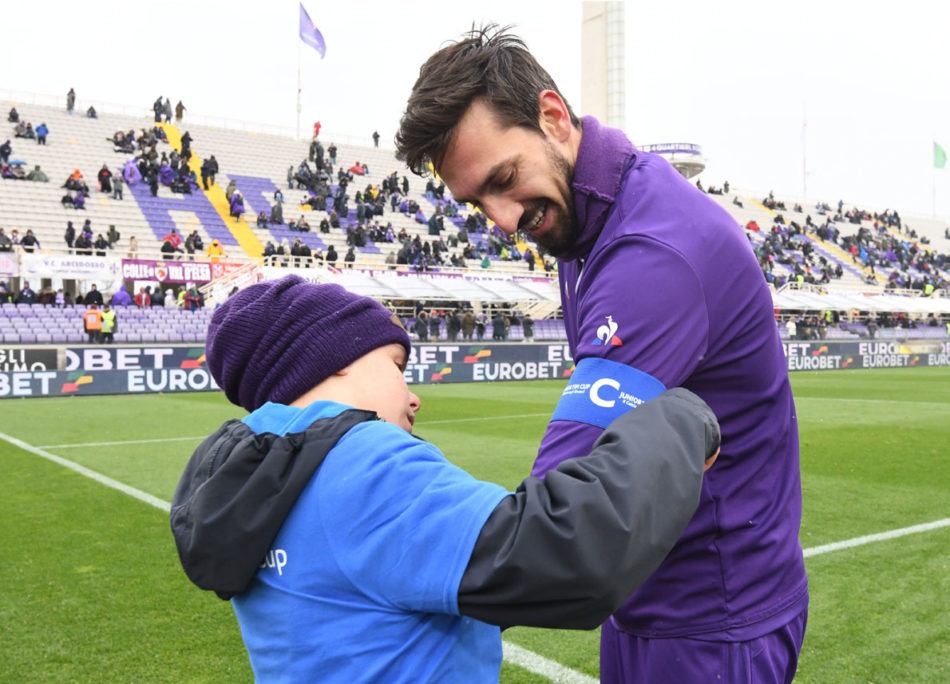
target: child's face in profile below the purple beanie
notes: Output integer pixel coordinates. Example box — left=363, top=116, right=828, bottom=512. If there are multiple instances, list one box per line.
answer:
left=348, top=343, right=422, bottom=432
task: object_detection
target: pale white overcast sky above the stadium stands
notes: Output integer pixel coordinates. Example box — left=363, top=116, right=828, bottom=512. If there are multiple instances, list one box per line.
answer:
left=0, top=0, right=950, bottom=222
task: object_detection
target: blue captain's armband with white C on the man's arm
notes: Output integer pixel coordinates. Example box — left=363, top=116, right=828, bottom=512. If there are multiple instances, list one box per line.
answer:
left=551, top=357, right=666, bottom=428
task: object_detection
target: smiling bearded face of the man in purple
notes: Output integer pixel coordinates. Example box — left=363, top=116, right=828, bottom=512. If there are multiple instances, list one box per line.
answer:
left=438, top=99, right=578, bottom=256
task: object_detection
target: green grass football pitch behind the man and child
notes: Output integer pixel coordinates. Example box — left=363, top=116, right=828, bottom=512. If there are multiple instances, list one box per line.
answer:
left=0, top=368, right=950, bottom=683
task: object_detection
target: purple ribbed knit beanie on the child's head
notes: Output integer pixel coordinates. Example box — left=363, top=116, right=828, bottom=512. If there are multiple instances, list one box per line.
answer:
left=205, top=275, right=411, bottom=411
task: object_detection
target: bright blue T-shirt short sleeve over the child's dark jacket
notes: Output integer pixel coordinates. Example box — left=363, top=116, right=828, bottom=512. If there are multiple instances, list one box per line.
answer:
left=319, top=422, right=509, bottom=615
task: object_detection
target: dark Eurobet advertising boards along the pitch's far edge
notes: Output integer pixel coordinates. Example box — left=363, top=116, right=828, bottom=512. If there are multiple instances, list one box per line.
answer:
left=0, top=340, right=950, bottom=398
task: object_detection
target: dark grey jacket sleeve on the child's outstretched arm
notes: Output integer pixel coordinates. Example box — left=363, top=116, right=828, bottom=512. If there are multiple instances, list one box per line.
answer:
left=458, top=388, right=719, bottom=629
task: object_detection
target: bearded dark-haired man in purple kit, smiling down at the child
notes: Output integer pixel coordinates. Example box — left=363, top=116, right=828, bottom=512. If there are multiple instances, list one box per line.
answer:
left=397, top=27, right=808, bottom=682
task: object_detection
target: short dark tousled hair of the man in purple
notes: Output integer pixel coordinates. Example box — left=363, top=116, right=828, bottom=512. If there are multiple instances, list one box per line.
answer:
left=396, top=24, right=580, bottom=176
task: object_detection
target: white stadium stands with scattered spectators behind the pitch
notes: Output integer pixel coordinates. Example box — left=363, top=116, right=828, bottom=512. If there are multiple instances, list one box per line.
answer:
left=0, top=93, right=950, bottom=344
